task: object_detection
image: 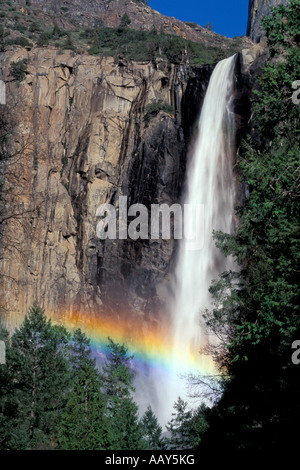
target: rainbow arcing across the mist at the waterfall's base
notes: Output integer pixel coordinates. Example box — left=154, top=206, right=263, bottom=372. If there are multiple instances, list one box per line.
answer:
left=52, top=312, right=216, bottom=375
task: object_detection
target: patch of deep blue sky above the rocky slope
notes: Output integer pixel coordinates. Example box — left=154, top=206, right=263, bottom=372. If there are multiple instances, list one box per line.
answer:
left=149, top=0, right=249, bottom=37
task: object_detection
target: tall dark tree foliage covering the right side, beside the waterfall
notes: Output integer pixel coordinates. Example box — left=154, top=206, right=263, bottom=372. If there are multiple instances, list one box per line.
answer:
left=199, top=0, right=300, bottom=450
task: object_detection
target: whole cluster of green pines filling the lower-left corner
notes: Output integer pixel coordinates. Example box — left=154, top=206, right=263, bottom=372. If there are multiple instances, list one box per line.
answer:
left=0, top=303, right=159, bottom=450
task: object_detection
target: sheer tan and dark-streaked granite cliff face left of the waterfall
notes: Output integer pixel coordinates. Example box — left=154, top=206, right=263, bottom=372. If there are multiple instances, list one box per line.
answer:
left=1, top=48, right=212, bottom=324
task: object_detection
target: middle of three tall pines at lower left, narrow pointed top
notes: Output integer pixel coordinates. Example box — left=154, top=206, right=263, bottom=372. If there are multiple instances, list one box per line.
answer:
left=58, top=329, right=107, bottom=450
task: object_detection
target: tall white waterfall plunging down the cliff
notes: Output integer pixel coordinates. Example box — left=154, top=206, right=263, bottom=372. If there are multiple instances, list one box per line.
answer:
left=158, top=56, right=235, bottom=422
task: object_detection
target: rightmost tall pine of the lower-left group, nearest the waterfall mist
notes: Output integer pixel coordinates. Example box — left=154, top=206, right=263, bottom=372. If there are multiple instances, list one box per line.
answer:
left=101, top=338, right=145, bottom=450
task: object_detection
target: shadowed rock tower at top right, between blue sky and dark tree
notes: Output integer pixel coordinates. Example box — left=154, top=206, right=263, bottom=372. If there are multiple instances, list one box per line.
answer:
left=247, top=0, right=290, bottom=42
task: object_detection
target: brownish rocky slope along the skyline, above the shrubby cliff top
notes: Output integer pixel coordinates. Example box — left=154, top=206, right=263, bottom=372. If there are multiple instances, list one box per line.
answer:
left=13, top=0, right=251, bottom=49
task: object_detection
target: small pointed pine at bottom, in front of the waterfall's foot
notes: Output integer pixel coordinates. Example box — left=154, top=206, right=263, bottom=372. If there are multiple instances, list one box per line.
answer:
left=166, top=397, right=192, bottom=450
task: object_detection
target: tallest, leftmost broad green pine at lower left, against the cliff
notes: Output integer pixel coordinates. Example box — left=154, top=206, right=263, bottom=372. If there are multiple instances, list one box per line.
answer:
left=6, top=303, right=67, bottom=450
